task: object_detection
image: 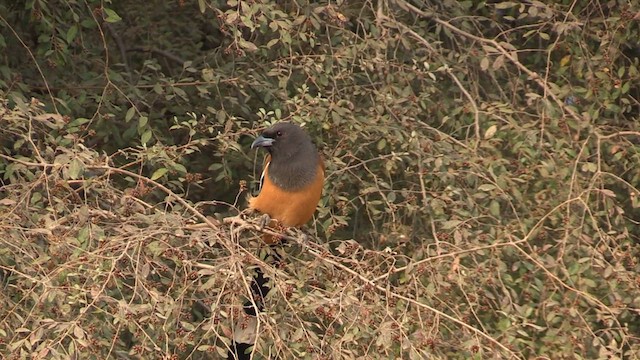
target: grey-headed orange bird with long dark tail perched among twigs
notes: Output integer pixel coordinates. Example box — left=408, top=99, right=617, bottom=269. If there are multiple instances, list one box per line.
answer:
left=228, top=122, right=325, bottom=360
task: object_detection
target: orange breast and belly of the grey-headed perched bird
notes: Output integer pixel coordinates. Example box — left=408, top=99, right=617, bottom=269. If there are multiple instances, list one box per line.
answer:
left=249, top=161, right=324, bottom=227
